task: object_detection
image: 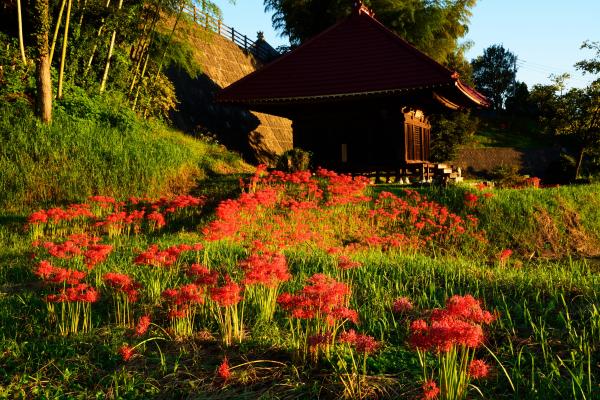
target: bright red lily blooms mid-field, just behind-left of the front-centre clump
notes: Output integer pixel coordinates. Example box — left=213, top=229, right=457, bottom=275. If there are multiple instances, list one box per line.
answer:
left=240, top=252, right=291, bottom=287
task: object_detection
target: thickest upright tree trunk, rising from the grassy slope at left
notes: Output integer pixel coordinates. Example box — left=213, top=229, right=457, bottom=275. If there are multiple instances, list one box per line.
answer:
left=33, top=0, right=52, bottom=124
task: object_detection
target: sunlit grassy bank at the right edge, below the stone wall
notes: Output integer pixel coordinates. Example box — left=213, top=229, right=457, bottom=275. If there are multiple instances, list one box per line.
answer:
left=376, top=184, right=600, bottom=258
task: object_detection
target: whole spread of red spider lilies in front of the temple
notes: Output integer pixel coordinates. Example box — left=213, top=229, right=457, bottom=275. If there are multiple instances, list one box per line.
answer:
left=27, top=167, right=493, bottom=398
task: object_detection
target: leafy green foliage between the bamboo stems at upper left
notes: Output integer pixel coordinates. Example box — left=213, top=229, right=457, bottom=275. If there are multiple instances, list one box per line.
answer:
left=0, top=0, right=206, bottom=119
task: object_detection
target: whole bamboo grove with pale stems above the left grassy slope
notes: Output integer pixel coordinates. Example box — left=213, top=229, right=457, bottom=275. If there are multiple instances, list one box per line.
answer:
left=0, top=0, right=220, bottom=121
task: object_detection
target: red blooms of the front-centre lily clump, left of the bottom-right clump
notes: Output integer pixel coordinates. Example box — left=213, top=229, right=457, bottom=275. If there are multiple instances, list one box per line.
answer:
left=277, top=274, right=358, bottom=320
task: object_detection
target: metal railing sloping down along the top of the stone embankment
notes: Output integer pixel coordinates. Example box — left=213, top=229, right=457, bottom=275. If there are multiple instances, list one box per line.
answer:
left=183, top=6, right=277, bottom=63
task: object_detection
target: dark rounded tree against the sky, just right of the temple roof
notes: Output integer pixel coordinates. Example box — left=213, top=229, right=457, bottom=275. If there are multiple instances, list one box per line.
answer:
left=471, top=44, right=517, bottom=110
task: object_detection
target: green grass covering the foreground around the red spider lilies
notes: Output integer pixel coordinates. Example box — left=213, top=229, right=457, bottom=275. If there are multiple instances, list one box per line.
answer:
left=0, top=180, right=600, bottom=399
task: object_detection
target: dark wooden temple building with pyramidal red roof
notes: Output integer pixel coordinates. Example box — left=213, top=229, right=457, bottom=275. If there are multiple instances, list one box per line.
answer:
left=217, top=2, right=488, bottom=178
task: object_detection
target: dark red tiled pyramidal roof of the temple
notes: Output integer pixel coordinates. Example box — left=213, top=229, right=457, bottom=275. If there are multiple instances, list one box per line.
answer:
left=217, top=8, right=487, bottom=106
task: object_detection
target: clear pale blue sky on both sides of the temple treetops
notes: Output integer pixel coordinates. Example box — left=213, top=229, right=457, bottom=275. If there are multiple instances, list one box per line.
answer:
left=215, top=0, right=600, bottom=87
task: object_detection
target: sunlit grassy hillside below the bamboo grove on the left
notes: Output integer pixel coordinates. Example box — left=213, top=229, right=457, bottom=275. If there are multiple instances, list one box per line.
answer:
left=0, top=97, right=251, bottom=209
